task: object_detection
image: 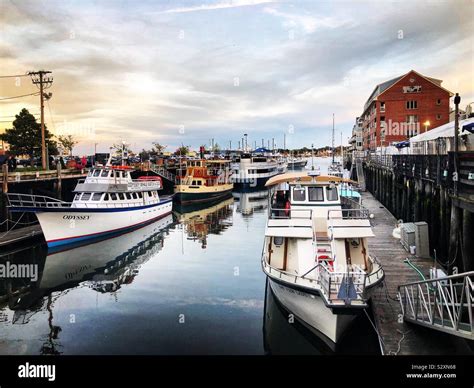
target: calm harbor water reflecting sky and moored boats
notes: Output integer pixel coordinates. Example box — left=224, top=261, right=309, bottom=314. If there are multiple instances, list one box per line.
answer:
left=0, top=159, right=378, bottom=354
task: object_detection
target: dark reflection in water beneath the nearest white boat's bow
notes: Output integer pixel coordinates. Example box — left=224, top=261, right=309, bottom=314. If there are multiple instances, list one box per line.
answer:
left=263, top=279, right=380, bottom=355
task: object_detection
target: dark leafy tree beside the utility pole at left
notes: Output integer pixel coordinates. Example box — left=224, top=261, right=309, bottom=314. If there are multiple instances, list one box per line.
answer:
left=0, top=108, right=58, bottom=165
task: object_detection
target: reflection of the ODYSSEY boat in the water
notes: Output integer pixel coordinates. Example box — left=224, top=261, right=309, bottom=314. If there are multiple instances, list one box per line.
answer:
left=0, top=214, right=174, bottom=354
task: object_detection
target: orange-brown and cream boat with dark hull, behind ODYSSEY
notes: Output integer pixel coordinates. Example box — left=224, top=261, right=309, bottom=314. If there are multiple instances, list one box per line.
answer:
left=174, top=159, right=233, bottom=204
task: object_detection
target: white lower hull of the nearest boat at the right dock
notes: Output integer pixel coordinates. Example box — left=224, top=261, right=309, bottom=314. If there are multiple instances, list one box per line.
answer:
left=269, top=278, right=356, bottom=343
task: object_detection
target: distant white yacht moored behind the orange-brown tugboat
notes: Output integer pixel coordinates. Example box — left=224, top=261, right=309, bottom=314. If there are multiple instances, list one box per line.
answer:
left=230, top=153, right=286, bottom=191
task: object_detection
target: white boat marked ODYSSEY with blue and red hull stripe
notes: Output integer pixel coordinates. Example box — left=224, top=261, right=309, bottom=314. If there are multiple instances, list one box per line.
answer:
left=7, top=166, right=173, bottom=247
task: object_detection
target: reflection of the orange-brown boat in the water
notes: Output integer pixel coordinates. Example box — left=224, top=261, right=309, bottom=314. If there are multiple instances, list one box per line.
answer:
left=174, top=194, right=234, bottom=249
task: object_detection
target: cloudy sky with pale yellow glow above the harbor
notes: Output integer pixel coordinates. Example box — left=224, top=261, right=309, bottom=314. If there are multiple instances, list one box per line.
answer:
left=0, top=0, right=474, bottom=153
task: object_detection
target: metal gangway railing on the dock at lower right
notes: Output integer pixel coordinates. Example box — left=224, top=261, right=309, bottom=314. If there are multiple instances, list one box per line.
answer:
left=398, top=271, right=474, bottom=340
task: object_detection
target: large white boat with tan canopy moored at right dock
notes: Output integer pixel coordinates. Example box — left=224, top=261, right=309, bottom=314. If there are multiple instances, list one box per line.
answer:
left=262, top=172, right=384, bottom=344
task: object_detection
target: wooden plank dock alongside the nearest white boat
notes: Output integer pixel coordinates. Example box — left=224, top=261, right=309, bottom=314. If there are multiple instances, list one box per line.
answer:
left=362, top=192, right=473, bottom=355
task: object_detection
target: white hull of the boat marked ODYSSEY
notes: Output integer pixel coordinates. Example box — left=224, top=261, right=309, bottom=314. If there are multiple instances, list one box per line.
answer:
left=36, top=199, right=173, bottom=247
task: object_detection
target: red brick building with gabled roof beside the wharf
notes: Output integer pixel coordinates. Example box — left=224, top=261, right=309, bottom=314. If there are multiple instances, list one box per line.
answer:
left=360, top=70, right=453, bottom=150
